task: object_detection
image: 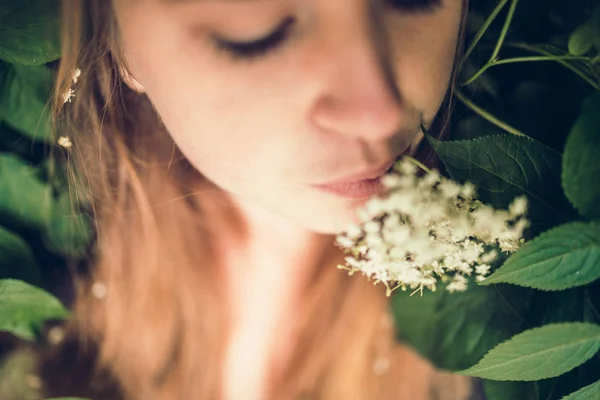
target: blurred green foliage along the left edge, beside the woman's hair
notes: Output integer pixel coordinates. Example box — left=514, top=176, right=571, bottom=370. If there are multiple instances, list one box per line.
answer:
left=0, top=0, right=91, bottom=350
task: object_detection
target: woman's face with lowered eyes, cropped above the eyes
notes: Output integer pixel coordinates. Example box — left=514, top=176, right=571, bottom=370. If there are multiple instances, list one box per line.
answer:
left=113, top=0, right=462, bottom=233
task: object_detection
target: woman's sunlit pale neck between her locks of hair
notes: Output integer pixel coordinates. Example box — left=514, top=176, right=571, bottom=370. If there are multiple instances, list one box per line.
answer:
left=199, top=186, right=338, bottom=398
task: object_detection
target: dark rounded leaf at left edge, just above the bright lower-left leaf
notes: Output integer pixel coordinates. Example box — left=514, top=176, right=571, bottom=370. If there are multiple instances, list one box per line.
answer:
left=0, top=226, right=42, bottom=285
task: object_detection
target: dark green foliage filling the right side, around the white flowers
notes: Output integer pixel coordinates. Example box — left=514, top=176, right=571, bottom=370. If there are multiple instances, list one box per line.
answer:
left=392, top=0, right=600, bottom=400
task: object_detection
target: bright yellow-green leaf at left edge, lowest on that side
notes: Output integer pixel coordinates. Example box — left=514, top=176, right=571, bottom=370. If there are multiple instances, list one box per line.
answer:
left=0, top=279, right=69, bottom=340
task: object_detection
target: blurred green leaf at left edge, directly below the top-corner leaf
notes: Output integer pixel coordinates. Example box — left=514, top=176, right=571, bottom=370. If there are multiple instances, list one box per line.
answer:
left=0, top=65, right=53, bottom=141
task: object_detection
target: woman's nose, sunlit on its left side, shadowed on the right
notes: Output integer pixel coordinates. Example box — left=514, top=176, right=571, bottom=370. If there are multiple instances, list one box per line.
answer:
left=311, top=10, right=406, bottom=142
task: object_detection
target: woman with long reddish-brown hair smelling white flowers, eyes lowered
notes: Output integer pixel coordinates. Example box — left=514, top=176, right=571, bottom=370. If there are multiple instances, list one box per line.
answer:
left=43, top=0, right=469, bottom=400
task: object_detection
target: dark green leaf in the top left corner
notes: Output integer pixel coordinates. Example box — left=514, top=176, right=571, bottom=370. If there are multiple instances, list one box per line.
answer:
left=0, top=0, right=60, bottom=65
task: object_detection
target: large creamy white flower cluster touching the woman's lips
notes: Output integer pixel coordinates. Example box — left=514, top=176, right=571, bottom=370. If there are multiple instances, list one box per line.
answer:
left=336, top=157, right=529, bottom=296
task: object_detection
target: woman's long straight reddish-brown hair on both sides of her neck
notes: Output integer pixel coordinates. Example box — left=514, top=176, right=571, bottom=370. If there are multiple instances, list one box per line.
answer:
left=43, top=0, right=468, bottom=400
